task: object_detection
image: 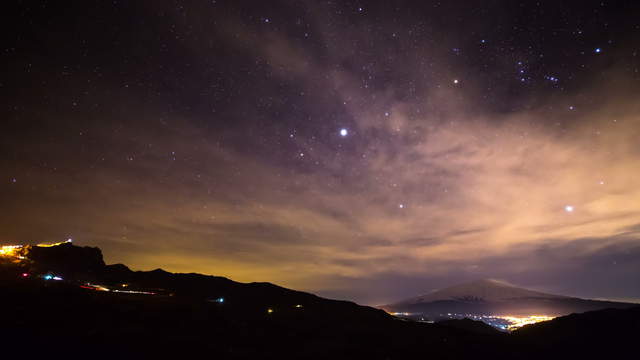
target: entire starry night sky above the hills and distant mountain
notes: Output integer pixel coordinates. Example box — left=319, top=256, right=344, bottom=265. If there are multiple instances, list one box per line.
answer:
left=0, top=0, right=640, bottom=305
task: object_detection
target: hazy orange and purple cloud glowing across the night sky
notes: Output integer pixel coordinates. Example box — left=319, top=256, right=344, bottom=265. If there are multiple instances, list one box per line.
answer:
left=5, top=0, right=640, bottom=303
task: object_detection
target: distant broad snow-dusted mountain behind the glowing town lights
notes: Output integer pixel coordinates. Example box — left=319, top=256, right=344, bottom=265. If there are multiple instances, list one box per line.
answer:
left=381, top=279, right=637, bottom=319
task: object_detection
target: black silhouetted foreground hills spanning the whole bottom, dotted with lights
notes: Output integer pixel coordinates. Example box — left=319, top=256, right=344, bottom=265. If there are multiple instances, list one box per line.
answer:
left=0, top=244, right=640, bottom=359
